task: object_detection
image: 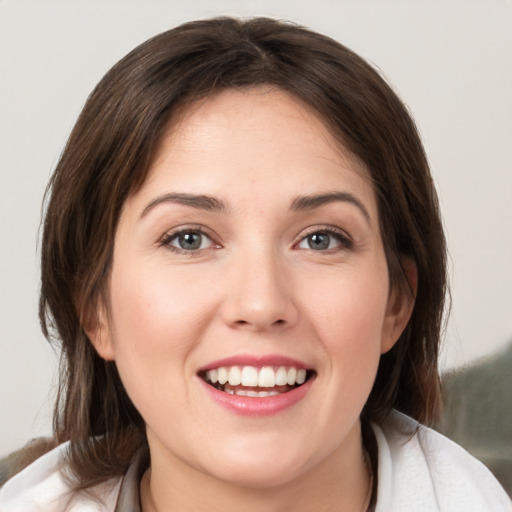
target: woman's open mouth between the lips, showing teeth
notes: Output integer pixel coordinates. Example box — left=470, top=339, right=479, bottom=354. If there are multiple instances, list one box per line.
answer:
left=198, top=365, right=316, bottom=398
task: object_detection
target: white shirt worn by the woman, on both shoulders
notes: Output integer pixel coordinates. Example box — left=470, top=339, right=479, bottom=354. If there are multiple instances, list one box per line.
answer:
left=0, top=411, right=512, bottom=512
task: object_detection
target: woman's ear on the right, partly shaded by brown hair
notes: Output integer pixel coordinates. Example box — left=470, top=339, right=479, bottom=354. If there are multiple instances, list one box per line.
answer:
left=380, top=257, right=418, bottom=354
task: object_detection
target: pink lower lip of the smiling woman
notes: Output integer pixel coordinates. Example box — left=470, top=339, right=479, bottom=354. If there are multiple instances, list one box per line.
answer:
left=198, top=377, right=315, bottom=416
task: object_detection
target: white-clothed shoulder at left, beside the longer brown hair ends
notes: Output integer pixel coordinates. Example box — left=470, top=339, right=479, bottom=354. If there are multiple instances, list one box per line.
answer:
left=0, top=443, right=121, bottom=512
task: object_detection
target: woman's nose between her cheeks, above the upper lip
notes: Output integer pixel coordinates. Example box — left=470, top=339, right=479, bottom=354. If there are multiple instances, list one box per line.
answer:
left=222, top=251, right=298, bottom=332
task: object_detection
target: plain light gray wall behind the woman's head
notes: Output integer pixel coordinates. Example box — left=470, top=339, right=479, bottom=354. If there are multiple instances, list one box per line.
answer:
left=0, top=0, right=512, bottom=455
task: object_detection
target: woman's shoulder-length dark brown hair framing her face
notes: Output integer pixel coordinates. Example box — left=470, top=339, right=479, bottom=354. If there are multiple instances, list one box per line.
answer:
left=33, top=18, right=446, bottom=488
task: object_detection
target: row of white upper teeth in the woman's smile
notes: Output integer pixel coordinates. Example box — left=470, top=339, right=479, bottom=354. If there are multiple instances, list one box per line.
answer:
left=206, top=366, right=306, bottom=388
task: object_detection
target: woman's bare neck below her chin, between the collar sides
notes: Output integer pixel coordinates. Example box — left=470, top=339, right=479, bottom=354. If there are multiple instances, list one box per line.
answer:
left=141, top=422, right=372, bottom=512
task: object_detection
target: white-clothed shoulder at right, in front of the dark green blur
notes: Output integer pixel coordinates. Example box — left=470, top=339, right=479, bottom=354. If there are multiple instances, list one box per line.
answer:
left=372, top=411, right=512, bottom=512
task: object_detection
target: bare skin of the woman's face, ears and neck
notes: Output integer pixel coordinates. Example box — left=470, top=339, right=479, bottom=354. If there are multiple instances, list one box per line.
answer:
left=89, top=88, right=412, bottom=512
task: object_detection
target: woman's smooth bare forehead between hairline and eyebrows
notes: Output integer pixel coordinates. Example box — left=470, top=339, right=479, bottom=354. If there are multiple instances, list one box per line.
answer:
left=130, top=86, right=373, bottom=216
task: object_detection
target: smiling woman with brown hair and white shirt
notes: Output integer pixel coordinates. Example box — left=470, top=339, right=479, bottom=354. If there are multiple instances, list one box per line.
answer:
left=0, top=18, right=511, bottom=512
